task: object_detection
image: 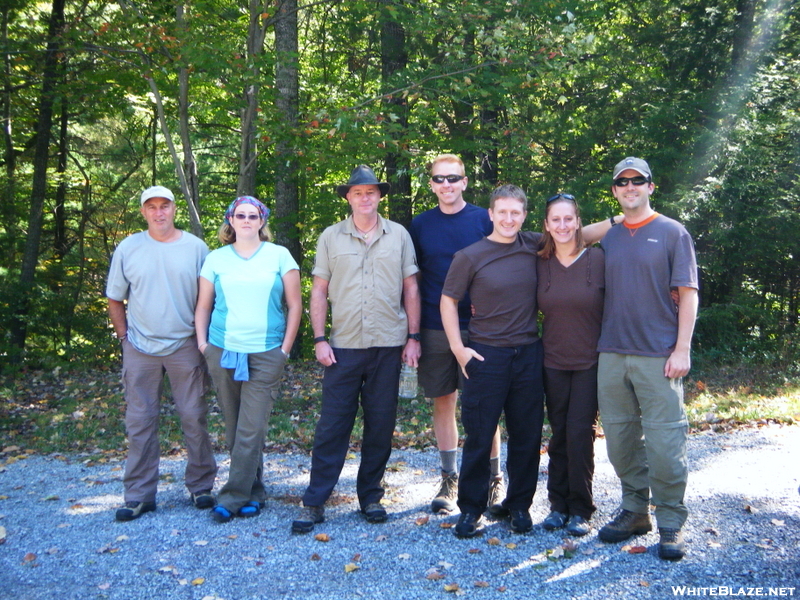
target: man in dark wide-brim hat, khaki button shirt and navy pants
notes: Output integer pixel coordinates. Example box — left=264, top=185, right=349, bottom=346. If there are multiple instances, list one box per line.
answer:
left=292, top=165, right=420, bottom=533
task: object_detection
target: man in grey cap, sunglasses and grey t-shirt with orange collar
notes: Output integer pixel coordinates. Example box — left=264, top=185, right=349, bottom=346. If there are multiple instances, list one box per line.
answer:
left=598, top=157, right=698, bottom=560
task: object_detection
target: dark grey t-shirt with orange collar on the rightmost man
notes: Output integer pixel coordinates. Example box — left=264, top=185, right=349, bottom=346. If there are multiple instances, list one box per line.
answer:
left=597, top=215, right=697, bottom=356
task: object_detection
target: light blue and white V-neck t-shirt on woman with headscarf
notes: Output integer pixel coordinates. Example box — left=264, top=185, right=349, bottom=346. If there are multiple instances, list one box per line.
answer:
left=200, top=242, right=299, bottom=354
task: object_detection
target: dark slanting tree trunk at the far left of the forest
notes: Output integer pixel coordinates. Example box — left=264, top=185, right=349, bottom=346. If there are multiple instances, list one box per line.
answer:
left=11, top=0, right=66, bottom=354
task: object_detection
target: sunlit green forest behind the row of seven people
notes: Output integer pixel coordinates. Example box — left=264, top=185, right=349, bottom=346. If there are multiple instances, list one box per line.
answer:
left=0, top=0, right=800, bottom=383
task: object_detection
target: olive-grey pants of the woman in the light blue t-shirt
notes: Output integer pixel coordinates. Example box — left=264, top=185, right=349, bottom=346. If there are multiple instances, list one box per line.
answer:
left=204, top=344, right=286, bottom=513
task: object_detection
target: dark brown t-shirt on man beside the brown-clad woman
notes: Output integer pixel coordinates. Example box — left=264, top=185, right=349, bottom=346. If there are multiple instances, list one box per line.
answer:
left=442, top=231, right=542, bottom=348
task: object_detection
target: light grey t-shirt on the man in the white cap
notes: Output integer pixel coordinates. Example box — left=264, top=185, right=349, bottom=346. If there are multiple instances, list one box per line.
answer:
left=106, top=231, right=208, bottom=356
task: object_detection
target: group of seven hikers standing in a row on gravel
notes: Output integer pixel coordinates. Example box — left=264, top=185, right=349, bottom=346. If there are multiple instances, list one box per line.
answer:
left=106, top=154, right=698, bottom=560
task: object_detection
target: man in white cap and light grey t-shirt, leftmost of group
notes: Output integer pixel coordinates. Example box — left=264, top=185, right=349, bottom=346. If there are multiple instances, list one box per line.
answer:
left=106, top=185, right=217, bottom=521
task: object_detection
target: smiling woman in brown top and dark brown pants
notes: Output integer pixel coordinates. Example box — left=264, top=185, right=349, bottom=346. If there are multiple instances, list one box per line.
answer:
left=537, top=194, right=614, bottom=536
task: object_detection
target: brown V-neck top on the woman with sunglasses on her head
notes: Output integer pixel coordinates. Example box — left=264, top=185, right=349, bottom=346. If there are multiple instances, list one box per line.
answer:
left=537, top=248, right=605, bottom=371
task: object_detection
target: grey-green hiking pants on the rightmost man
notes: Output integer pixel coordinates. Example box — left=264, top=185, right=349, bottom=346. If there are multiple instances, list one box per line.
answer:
left=597, top=352, right=689, bottom=529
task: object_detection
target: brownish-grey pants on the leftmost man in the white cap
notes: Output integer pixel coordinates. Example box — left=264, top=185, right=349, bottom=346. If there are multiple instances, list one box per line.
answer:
left=122, top=337, right=217, bottom=502
